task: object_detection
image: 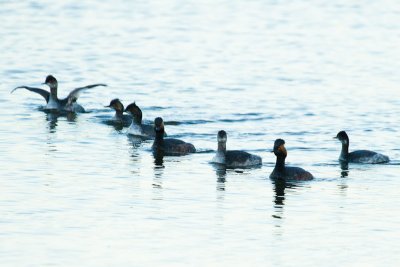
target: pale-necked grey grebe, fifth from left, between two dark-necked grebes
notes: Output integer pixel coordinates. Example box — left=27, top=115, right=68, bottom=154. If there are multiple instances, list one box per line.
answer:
left=211, top=130, right=262, bottom=168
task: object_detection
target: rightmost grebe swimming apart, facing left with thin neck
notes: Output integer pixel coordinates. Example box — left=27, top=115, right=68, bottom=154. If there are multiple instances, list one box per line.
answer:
left=334, top=131, right=389, bottom=164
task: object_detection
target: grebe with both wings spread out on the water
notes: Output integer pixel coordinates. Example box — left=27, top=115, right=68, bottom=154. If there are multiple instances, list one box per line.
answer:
left=11, top=75, right=107, bottom=112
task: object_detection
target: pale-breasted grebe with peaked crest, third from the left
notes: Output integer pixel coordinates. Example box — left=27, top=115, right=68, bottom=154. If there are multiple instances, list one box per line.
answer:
left=125, top=102, right=156, bottom=138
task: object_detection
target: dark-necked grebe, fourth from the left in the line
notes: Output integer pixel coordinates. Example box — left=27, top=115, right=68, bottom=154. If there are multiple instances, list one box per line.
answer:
left=152, top=117, right=196, bottom=156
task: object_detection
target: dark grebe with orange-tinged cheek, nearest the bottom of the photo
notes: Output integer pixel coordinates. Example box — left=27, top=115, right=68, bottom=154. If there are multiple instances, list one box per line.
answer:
left=269, top=139, right=314, bottom=180
